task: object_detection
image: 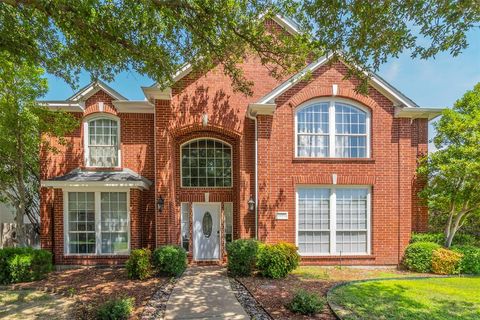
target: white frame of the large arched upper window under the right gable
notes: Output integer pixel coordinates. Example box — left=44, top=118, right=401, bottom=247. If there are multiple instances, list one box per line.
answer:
left=294, top=97, right=371, bottom=159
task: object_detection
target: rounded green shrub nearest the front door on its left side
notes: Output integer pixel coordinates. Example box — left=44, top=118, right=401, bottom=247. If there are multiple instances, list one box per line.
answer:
left=153, top=245, right=187, bottom=277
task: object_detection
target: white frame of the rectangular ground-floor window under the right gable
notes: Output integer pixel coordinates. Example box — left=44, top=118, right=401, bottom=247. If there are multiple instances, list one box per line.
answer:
left=295, top=185, right=372, bottom=257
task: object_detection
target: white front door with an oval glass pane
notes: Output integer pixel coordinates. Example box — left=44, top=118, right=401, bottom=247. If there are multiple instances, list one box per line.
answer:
left=193, top=203, right=221, bottom=260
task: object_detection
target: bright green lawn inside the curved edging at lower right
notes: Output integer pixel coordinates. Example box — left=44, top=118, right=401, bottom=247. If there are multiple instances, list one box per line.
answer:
left=329, top=277, right=480, bottom=320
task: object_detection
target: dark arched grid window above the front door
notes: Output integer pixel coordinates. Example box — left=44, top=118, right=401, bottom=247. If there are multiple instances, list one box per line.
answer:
left=181, top=139, right=232, bottom=188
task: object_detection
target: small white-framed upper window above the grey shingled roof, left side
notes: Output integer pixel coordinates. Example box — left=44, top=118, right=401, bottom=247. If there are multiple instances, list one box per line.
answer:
left=85, top=117, right=120, bottom=167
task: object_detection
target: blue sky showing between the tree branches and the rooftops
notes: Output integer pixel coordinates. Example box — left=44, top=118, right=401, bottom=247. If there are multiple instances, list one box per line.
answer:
left=44, top=29, right=480, bottom=148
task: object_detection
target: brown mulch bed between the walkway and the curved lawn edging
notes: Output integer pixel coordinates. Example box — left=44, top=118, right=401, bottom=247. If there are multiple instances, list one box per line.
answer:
left=237, top=275, right=338, bottom=320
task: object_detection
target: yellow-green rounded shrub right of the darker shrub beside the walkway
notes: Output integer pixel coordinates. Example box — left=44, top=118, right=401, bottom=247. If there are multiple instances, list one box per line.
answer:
left=257, top=243, right=300, bottom=279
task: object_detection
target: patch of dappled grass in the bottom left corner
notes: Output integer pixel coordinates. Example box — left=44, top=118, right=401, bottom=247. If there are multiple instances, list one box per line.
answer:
left=0, top=290, right=72, bottom=320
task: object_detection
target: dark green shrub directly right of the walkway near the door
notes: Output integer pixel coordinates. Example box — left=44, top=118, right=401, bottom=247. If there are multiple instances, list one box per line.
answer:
left=227, top=239, right=258, bottom=276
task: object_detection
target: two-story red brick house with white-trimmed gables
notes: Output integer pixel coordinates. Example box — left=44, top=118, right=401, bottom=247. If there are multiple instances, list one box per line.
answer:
left=41, top=18, right=440, bottom=265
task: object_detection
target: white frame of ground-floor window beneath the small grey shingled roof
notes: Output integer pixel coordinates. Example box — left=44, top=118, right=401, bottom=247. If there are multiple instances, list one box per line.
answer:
left=63, top=188, right=131, bottom=256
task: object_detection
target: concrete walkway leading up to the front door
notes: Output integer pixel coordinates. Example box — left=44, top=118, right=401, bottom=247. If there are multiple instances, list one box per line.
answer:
left=165, top=266, right=250, bottom=320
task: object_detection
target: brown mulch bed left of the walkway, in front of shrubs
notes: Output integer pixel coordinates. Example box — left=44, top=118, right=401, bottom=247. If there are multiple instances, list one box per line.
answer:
left=13, top=268, right=169, bottom=319
